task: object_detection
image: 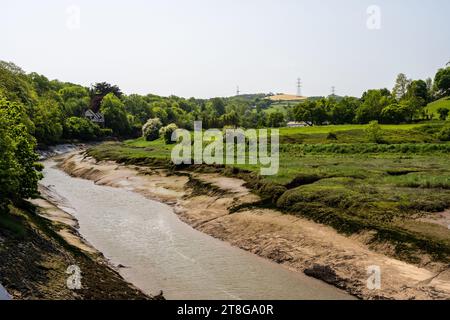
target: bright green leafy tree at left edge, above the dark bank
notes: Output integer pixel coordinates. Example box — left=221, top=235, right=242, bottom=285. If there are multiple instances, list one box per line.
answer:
left=0, top=96, right=42, bottom=211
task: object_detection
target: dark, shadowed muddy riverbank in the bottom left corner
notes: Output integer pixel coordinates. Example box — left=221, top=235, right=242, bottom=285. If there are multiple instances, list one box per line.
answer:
left=0, top=201, right=152, bottom=300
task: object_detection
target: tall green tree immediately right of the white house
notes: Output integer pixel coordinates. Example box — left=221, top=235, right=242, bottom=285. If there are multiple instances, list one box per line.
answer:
left=100, top=93, right=130, bottom=136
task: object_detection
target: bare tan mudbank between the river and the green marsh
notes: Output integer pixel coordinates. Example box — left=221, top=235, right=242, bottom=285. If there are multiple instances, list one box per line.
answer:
left=60, top=153, right=450, bottom=299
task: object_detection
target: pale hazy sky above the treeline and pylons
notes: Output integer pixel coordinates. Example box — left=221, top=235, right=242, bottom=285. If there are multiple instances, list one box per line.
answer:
left=0, top=0, right=450, bottom=98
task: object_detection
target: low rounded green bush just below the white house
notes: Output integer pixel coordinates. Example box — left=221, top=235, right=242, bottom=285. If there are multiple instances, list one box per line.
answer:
left=64, top=117, right=102, bottom=141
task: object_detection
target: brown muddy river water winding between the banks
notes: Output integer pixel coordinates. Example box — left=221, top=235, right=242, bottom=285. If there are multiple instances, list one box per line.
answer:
left=42, top=160, right=351, bottom=299
